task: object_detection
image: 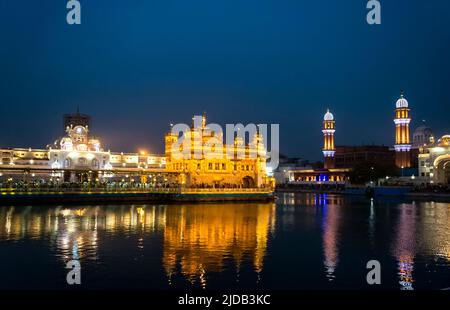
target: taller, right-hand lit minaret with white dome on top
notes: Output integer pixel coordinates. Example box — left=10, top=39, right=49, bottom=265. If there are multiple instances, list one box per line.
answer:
left=394, top=92, right=411, bottom=168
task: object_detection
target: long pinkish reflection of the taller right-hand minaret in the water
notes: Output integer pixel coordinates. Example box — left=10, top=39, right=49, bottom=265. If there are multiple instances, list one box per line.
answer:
left=393, top=203, right=416, bottom=290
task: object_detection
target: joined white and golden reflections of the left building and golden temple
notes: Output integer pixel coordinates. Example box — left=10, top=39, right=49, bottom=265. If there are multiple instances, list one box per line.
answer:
left=0, top=203, right=275, bottom=287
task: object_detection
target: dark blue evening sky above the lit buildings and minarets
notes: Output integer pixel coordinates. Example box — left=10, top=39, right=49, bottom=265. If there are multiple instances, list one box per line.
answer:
left=0, top=0, right=450, bottom=159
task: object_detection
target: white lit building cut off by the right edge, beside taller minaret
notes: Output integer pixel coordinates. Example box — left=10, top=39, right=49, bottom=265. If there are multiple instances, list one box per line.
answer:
left=419, top=135, right=450, bottom=184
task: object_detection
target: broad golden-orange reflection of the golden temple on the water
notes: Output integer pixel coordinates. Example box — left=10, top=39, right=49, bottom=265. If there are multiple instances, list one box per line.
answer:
left=163, top=204, right=275, bottom=287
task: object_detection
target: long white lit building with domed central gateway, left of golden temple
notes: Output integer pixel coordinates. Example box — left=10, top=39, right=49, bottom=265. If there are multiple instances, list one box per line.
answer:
left=0, top=115, right=165, bottom=183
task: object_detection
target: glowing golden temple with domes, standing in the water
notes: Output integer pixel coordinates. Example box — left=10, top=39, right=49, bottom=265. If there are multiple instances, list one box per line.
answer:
left=165, top=115, right=273, bottom=188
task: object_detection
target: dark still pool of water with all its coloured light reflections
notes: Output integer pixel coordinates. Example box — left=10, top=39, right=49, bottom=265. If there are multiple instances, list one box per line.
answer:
left=0, top=193, right=450, bottom=290
